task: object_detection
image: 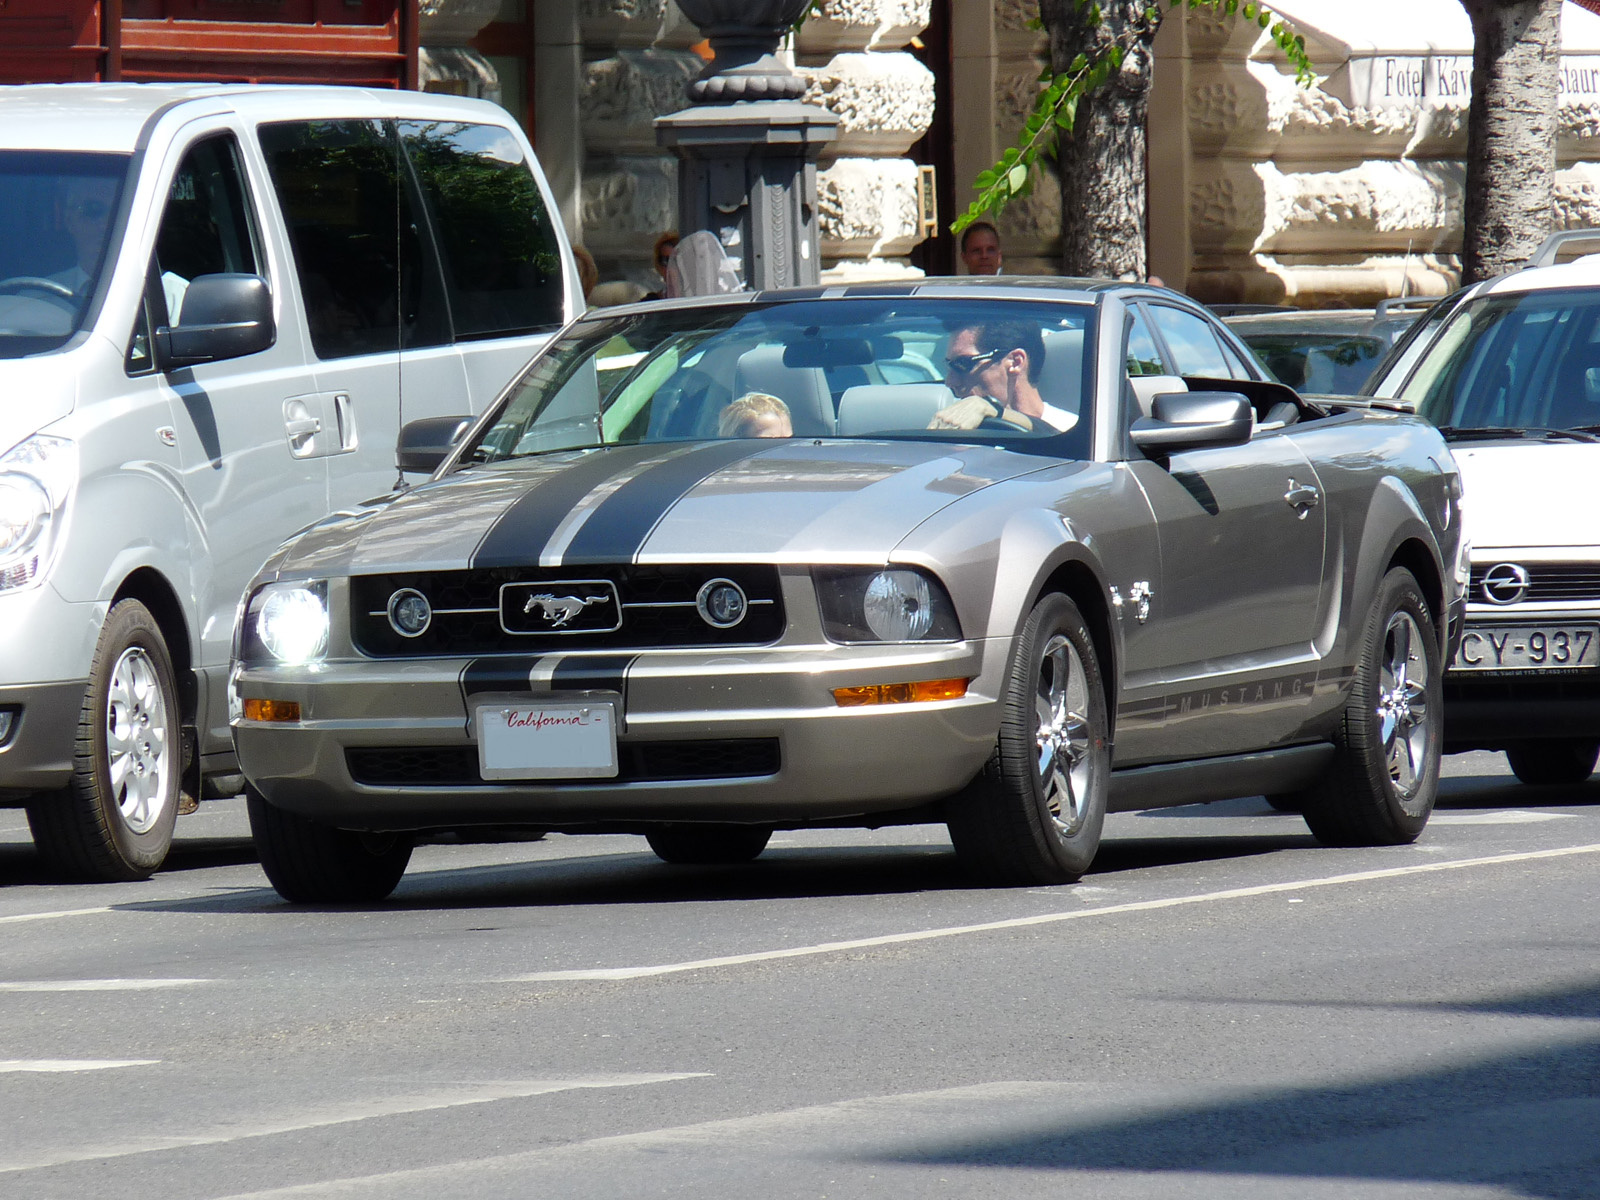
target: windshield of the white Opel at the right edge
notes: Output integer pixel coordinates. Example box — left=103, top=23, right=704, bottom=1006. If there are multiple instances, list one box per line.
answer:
left=1400, top=290, right=1600, bottom=434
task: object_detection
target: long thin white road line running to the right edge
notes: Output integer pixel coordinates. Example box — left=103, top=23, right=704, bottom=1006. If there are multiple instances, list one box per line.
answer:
left=505, top=843, right=1600, bottom=984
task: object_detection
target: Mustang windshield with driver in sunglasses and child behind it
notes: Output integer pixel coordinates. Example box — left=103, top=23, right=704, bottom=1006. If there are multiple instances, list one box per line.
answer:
left=461, top=298, right=1094, bottom=462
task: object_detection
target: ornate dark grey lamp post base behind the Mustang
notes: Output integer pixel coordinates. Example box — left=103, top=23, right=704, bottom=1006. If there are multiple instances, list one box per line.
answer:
left=656, top=0, right=838, bottom=290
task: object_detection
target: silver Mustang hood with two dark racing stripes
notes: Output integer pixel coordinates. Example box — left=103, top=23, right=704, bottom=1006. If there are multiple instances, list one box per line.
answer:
left=280, top=440, right=1056, bottom=574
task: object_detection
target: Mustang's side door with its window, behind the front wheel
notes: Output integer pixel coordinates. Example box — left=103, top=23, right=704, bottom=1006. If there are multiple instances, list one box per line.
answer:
left=1130, top=304, right=1326, bottom=758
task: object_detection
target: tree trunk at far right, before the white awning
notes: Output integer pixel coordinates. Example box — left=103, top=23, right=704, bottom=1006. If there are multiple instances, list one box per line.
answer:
left=1459, top=0, right=1562, bottom=283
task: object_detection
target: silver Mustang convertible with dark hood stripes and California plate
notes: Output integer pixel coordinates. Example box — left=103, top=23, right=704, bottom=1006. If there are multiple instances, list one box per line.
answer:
left=232, top=280, right=1466, bottom=901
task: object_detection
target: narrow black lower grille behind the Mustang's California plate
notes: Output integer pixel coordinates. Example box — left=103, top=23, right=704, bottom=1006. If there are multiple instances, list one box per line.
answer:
left=344, top=738, right=781, bottom=787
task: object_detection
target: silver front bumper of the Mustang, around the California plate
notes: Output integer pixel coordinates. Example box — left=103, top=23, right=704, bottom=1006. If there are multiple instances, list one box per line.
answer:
left=234, top=638, right=1010, bottom=829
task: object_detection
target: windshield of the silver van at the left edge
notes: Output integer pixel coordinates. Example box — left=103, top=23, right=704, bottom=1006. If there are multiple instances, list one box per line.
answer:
left=0, top=150, right=128, bottom=358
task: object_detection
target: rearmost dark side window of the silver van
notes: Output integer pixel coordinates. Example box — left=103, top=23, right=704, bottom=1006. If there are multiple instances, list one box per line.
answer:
left=400, top=122, right=562, bottom=339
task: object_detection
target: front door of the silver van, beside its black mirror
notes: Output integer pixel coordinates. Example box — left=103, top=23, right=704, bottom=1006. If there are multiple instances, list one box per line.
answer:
left=146, top=118, right=328, bottom=761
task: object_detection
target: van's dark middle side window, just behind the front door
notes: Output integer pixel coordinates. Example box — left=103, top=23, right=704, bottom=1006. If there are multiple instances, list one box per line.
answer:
left=261, top=120, right=450, bottom=358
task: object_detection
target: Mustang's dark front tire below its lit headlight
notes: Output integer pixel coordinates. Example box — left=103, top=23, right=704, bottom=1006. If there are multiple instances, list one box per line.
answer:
left=245, top=787, right=413, bottom=904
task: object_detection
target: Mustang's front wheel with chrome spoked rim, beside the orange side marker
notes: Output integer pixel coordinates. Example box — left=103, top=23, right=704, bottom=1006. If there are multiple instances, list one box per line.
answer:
left=949, top=594, right=1110, bottom=886
